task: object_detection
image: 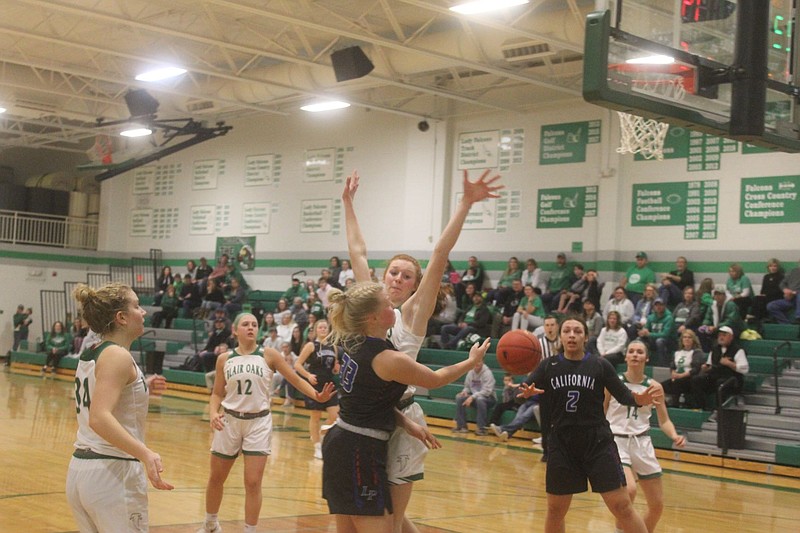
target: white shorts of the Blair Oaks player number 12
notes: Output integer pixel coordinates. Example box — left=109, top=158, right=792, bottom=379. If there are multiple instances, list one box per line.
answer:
left=211, top=413, right=272, bottom=459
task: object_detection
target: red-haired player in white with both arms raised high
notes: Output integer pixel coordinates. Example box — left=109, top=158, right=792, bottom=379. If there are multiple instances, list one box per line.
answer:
left=342, top=170, right=502, bottom=533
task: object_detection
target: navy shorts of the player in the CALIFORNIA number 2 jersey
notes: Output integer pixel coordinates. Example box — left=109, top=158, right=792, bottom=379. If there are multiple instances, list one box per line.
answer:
left=546, top=426, right=626, bottom=495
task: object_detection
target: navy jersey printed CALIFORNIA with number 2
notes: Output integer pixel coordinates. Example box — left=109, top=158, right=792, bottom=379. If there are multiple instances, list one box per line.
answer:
left=525, top=353, right=636, bottom=429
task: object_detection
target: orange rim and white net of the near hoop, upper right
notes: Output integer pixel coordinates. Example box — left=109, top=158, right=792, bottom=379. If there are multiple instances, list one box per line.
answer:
left=609, top=63, right=694, bottom=161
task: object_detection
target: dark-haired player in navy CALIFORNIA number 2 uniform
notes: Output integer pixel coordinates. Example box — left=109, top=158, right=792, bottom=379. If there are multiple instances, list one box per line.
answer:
left=520, top=318, right=663, bottom=533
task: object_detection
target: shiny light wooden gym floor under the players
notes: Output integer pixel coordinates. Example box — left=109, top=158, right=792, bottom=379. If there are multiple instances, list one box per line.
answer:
left=0, top=372, right=800, bottom=533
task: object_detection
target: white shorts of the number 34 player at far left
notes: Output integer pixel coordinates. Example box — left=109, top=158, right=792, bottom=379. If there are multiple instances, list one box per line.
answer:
left=67, top=457, right=148, bottom=533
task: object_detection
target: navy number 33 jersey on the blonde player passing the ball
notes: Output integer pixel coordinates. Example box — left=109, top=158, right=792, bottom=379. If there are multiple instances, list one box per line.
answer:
left=339, top=337, right=406, bottom=431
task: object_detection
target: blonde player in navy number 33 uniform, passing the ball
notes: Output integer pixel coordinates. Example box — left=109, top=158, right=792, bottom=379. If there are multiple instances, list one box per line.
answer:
left=322, top=282, right=489, bottom=533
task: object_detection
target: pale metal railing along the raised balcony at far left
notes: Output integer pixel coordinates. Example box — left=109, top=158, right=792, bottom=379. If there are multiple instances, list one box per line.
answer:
left=0, top=210, right=98, bottom=250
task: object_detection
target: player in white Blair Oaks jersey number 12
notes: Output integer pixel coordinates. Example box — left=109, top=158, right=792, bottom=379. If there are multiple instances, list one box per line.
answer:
left=199, top=313, right=334, bottom=533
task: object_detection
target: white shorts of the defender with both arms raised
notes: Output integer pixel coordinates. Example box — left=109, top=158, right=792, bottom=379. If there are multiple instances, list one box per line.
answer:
left=386, top=402, right=428, bottom=485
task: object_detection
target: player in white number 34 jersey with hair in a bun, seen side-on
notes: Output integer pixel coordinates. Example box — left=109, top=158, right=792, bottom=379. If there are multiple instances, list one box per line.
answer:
left=67, top=283, right=173, bottom=533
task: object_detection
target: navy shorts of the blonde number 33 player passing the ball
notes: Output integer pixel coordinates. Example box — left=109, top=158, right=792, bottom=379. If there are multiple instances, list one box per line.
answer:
left=322, top=425, right=392, bottom=516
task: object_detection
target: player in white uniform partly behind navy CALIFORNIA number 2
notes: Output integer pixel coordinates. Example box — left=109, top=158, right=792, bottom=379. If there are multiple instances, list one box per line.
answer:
left=605, top=339, right=686, bottom=533
